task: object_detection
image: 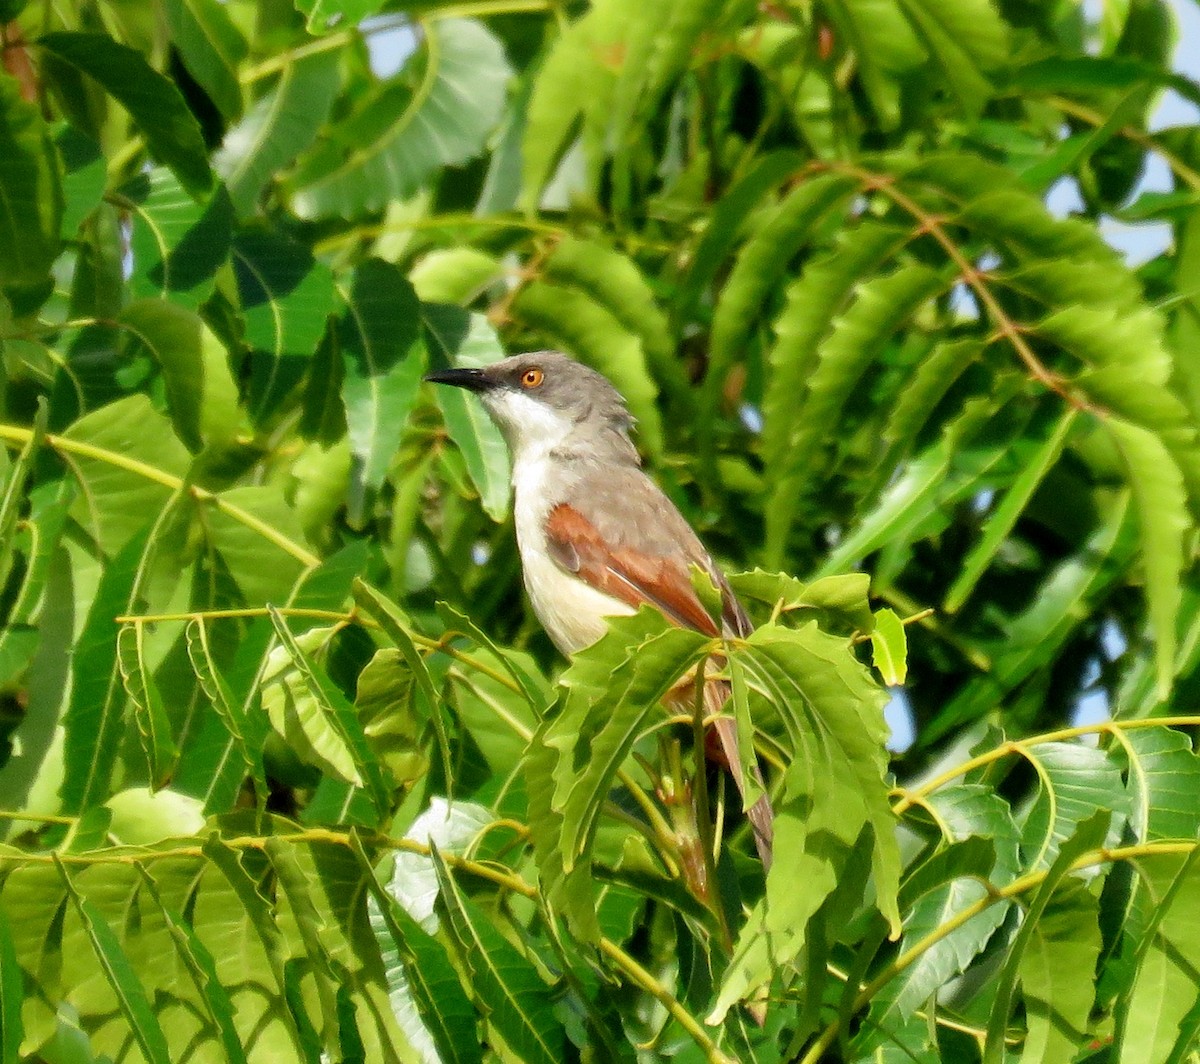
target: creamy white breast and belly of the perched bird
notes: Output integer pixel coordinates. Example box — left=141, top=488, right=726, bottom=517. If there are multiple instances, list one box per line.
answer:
left=512, top=449, right=634, bottom=654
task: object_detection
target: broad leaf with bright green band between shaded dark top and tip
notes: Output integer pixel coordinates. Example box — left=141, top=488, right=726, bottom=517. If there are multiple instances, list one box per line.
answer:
left=233, top=232, right=334, bottom=422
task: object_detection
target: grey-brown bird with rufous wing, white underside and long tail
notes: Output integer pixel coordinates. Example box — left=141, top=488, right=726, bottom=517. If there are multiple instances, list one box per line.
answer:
left=425, top=351, right=772, bottom=865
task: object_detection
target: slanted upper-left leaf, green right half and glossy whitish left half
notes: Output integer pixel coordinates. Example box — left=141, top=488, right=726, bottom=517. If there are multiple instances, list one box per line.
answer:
left=212, top=50, right=341, bottom=217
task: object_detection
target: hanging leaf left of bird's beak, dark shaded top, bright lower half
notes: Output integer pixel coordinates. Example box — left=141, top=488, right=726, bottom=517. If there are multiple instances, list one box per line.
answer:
left=341, top=259, right=425, bottom=525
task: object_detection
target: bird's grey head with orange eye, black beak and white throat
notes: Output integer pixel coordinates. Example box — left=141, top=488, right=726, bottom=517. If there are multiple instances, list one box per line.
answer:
left=425, top=351, right=637, bottom=462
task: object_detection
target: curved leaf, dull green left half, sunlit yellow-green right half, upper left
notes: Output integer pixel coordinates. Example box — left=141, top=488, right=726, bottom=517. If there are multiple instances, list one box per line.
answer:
left=120, top=300, right=241, bottom=453
